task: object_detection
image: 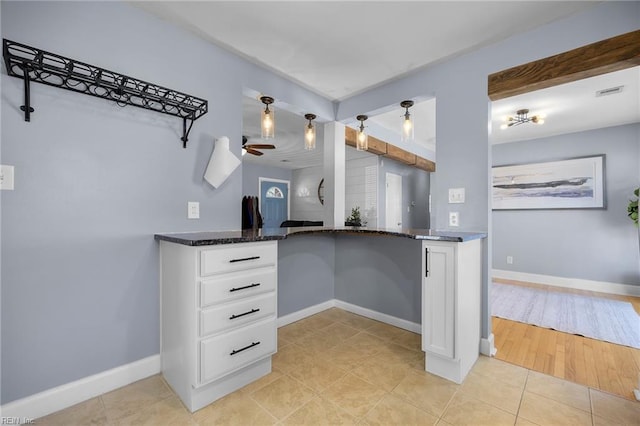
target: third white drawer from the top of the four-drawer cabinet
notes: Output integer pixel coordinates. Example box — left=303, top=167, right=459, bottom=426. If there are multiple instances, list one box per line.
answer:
left=200, top=292, right=276, bottom=337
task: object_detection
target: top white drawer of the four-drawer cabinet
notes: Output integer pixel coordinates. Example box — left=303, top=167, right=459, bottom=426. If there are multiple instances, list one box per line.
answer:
left=200, top=242, right=278, bottom=277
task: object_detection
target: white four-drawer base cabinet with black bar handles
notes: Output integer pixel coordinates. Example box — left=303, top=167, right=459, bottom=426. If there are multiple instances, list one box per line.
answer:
left=160, top=241, right=278, bottom=412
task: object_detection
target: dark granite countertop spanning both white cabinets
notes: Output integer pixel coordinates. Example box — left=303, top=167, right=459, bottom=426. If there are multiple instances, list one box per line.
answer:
left=154, top=226, right=487, bottom=246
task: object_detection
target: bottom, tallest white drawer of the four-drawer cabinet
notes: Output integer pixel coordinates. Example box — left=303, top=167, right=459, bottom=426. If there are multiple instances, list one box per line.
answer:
left=200, top=318, right=276, bottom=384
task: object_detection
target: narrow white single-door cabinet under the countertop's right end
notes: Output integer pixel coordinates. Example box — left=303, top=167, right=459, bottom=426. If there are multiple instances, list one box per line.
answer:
left=422, top=239, right=482, bottom=383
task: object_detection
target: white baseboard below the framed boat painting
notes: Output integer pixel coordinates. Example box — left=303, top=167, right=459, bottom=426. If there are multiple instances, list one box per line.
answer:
left=492, top=269, right=640, bottom=297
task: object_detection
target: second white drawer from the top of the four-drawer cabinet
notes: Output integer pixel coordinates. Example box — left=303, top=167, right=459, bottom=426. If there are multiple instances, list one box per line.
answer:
left=200, top=267, right=278, bottom=308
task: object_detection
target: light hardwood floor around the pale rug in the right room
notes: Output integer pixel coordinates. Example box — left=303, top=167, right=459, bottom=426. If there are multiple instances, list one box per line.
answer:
left=492, top=279, right=640, bottom=401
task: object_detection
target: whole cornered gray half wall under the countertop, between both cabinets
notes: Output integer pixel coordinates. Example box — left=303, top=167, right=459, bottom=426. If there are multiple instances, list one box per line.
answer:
left=278, top=234, right=422, bottom=324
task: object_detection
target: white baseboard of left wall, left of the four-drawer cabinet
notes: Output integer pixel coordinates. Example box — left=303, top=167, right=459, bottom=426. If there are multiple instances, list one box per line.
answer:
left=0, top=354, right=160, bottom=423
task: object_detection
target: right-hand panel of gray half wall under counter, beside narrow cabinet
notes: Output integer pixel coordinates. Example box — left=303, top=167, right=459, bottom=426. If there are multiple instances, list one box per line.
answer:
left=335, top=235, right=422, bottom=324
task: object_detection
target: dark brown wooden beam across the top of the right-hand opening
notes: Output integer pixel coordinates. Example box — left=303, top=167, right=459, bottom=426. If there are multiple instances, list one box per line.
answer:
left=488, top=30, right=640, bottom=101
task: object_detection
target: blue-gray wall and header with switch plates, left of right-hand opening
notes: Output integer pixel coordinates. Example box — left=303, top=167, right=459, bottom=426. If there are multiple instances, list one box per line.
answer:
left=337, top=2, right=640, bottom=337
